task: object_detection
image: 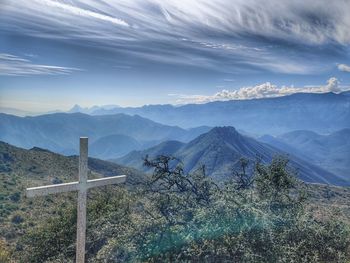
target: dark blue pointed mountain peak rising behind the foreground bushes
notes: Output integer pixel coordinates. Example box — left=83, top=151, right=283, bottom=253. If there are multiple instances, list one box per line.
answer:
left=116, top=127, right=347, bottom=185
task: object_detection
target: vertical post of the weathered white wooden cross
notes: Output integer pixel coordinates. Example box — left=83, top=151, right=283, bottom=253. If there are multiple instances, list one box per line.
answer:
left=76, top=137, right=88, bottom=263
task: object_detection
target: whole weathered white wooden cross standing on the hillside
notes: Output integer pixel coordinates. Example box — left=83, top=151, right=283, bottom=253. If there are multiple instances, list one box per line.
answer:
left=27, top=137, right=126, bottom=263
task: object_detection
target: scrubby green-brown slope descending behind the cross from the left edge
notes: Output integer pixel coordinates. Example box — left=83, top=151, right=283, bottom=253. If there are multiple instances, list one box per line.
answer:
left=0, top=142, right=144, bottom=245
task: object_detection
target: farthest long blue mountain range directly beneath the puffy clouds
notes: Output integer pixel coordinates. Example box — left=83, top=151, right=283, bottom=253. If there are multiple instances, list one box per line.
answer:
left=67, top=92, right=350, bottom=135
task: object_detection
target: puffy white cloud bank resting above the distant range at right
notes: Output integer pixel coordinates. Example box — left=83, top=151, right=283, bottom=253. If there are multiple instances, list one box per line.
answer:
left=174, top=77, right=341, bottom=103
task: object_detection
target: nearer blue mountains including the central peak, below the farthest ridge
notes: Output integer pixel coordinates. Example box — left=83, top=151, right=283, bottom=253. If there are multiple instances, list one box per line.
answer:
left=0, top=109, right=350, bottom=186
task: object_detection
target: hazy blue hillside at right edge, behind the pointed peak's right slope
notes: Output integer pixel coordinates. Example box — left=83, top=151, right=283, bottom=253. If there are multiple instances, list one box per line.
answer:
left=259, top=129, right=350, bottom=178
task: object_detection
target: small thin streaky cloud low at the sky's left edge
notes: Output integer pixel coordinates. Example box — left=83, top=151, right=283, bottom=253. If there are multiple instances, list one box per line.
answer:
left=0, top=53, right=80, bottom=76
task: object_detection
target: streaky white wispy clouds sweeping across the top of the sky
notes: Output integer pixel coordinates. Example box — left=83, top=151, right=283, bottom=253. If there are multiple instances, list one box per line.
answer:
left=0, top=0, right=350, bottom=74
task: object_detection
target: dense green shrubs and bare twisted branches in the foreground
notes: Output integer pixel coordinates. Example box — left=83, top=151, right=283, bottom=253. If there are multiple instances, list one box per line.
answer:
left=9, top=156, right=350, bottom=262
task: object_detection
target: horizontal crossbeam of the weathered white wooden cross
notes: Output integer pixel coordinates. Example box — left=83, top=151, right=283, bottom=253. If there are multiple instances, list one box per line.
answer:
left=26, top=175, right=126, bottom=197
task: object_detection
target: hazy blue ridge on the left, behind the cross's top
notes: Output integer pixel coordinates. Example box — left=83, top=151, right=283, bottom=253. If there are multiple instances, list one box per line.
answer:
left=0, top=113, right=209, bottom=158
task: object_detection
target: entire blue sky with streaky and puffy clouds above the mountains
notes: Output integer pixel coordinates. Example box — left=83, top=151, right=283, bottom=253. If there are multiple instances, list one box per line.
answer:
left=0, top=0, right=350, bottom=112
